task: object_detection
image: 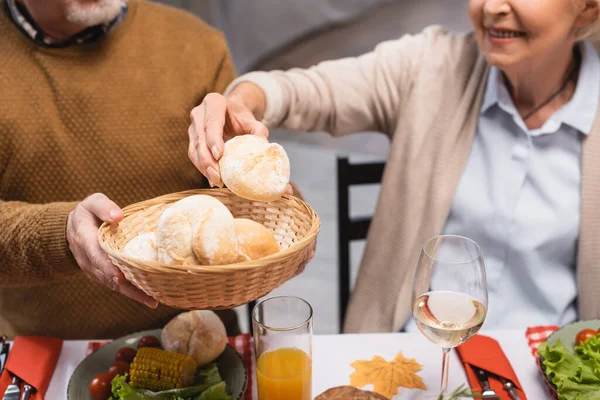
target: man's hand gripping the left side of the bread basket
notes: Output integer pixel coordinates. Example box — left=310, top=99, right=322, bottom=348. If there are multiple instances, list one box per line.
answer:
left=67, top=193, right=158, bottom=308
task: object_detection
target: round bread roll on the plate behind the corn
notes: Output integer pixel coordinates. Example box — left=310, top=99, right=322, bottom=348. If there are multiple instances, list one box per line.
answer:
left=161, top=310, right=227, bottom=365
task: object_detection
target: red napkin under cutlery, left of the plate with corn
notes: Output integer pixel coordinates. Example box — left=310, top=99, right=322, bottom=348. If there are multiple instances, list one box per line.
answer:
left=0, top=336, right=63, bottom=400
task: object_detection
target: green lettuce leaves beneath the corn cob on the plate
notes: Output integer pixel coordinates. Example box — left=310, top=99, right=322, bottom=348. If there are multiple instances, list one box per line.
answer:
left=111, top=364, right=231, bottom=400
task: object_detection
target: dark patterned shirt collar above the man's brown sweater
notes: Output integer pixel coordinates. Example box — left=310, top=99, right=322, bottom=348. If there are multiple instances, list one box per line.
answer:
left=6, top=0, right=128, bottom=47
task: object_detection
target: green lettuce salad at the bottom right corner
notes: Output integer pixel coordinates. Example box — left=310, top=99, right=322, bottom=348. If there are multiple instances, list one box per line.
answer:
left=538, top=335, right=600, bottom=400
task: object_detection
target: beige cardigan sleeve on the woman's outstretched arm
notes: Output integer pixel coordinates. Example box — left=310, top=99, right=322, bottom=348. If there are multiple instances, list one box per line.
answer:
left=226, top=27, right=445, bottom=135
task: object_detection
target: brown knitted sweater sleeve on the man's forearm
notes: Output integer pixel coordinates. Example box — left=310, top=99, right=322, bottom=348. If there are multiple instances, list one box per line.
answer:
left=0, top=200, right=79, bottom=286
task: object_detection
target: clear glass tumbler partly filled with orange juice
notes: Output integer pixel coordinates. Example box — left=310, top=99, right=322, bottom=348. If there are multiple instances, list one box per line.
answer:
left=252, top=296, right=313, bottom=400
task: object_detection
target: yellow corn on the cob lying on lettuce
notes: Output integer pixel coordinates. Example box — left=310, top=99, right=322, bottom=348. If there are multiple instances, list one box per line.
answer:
left=129, top=347, right=198, bottom=392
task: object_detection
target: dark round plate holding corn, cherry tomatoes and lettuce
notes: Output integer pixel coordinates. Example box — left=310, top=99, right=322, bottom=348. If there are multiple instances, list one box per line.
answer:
left=67, top=329, right=248, bottom=400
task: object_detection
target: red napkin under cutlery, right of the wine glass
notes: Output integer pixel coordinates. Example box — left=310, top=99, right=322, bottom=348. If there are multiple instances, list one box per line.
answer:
left=456, top=335, right=527, bottom=400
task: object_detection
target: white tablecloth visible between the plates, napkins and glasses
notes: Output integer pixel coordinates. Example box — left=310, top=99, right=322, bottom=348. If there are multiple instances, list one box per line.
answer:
left=46, top=330, right=550, bottom=400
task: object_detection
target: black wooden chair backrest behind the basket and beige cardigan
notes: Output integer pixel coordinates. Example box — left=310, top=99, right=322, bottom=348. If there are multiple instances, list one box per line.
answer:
left=337, top=157, right=385, bottom=332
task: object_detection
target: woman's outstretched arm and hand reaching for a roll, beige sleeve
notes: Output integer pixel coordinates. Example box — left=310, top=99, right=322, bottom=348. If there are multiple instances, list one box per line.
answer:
left=188, top=27, right=450, bottom=186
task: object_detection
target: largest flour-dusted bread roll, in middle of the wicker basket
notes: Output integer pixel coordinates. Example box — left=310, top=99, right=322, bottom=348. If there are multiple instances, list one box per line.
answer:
left=157, top=195, right=238, bottom=265
